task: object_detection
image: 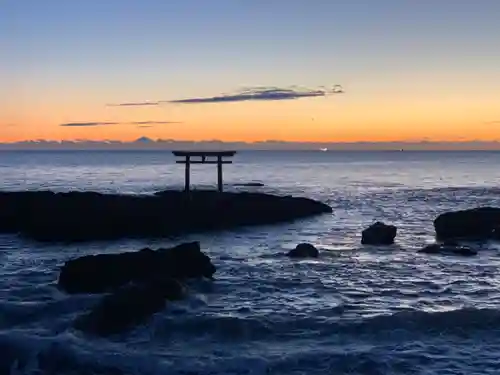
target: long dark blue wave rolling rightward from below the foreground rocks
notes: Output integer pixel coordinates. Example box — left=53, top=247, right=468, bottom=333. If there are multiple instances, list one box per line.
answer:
left=136, top=306, right=500, bottom=342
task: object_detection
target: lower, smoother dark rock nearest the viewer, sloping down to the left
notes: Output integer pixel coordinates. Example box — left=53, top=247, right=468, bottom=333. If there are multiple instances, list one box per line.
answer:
left=74, top=279, right=184, bottom=336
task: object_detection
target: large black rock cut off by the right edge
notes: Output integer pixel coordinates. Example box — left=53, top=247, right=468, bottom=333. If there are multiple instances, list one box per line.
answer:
left=434, top=207, right=500, bottom=240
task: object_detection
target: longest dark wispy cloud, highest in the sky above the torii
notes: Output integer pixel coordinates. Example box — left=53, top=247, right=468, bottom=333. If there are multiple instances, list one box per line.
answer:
left=110, top=85, right=344, bottom=107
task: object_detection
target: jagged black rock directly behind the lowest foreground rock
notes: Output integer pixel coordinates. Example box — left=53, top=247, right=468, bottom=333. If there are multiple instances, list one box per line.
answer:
left=58, top=242, right=216, bottom=293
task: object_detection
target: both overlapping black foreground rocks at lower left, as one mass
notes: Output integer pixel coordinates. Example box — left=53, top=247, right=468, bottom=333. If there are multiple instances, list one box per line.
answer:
left=62, top=242, right=216, bottom=336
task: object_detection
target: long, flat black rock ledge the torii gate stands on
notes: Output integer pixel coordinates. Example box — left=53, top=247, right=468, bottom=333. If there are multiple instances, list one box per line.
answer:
left=0, top=191, right=332, bottom=242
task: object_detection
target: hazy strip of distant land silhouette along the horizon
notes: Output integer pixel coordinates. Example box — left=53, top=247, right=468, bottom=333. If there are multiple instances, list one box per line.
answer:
left=0, top=137, right=500, bottom=151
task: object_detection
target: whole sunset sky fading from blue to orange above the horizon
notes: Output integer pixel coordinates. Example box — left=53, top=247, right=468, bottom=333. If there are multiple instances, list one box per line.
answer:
left=0, top=0, right=500, bottom=142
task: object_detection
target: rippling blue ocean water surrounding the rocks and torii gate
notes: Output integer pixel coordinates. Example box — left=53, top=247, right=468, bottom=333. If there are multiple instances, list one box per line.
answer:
left=0, top=151, right=500, bottom=375
